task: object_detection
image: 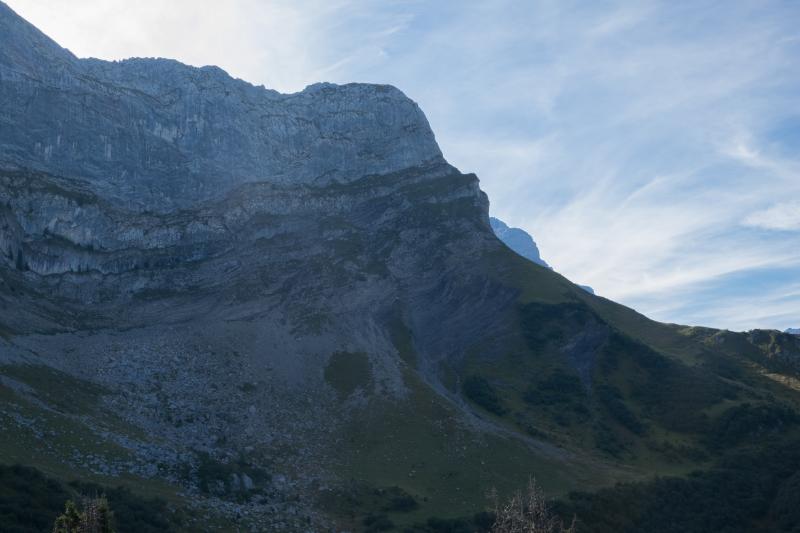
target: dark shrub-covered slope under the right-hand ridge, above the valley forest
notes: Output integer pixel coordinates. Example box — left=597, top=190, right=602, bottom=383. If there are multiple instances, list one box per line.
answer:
left=464, top=290, right=798, bottom=462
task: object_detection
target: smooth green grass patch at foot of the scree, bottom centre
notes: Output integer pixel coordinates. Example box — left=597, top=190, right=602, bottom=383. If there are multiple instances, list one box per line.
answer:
left=327, top=371, right=633, bottom=527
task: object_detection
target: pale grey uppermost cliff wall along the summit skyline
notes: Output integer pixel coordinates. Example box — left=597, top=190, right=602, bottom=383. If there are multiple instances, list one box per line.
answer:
left=0, top=2, right=444, bottom=210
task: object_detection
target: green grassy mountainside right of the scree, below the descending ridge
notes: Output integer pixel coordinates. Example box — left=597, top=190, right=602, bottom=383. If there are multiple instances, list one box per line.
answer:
left=328, top=245, right=800, bottom=528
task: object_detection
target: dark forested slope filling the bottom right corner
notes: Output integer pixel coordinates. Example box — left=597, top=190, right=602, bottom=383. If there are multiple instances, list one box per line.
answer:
left=558, top=438, right=800, bottom=533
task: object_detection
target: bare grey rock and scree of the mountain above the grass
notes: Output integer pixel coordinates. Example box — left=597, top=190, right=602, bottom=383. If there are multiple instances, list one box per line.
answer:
left=0, top=3, right=517, bottom=528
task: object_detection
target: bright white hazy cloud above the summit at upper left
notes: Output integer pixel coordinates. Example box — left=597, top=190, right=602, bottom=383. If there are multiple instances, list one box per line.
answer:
left=8, top=0, right=410, bottom=92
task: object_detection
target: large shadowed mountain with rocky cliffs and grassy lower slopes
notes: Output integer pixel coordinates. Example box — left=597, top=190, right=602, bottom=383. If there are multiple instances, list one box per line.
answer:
left=0, top=3, right=800, bottom=533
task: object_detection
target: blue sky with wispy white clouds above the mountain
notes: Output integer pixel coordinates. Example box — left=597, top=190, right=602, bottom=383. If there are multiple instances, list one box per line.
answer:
left=7, top=0, right=800, bottom=330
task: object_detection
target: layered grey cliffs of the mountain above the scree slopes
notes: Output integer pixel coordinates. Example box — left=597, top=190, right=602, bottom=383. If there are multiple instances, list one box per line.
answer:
left=0, top=1, right=494, bottom=312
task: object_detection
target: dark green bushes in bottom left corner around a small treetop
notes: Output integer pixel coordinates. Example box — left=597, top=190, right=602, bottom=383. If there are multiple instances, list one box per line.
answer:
left=0, top=465, right=181, bottom=533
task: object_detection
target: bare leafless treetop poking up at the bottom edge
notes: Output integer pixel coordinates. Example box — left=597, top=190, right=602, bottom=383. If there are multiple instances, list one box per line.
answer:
left=489, top=479, right=576, bottom=533
